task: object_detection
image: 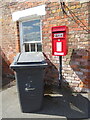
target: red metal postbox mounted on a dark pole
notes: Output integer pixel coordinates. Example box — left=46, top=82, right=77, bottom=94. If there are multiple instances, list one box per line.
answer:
left=52, top=26, right=68, bottom=56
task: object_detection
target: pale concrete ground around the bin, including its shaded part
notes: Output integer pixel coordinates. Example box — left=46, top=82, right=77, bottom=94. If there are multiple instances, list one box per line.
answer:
left=0, top=86, right=90, bottom=120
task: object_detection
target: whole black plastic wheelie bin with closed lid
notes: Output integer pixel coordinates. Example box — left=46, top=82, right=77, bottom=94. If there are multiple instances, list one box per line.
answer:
left=10, top=52, right=47, bottom=112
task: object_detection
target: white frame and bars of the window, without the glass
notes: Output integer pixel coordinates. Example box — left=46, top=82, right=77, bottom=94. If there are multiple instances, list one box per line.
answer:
left=19, top=17, right=42, bottom=52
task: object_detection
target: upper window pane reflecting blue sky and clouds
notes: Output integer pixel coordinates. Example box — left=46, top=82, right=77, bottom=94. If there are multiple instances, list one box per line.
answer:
left=22, top=20, right=41, bottom=42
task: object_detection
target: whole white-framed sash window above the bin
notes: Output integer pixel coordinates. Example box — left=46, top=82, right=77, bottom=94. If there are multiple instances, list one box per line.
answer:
left=20, top=19, right=42, bottom=52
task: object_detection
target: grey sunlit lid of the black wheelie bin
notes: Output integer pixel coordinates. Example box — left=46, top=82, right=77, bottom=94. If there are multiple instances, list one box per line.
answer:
left=10, top=52, right=47, bottom=69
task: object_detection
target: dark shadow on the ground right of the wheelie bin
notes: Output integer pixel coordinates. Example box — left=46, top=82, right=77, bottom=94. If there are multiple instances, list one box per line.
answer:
left=38, top=88, right=90, bottom=118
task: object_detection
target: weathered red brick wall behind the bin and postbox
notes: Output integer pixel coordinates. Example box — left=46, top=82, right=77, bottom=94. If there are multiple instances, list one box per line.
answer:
left=0, top=1, right=90, bottom=92
